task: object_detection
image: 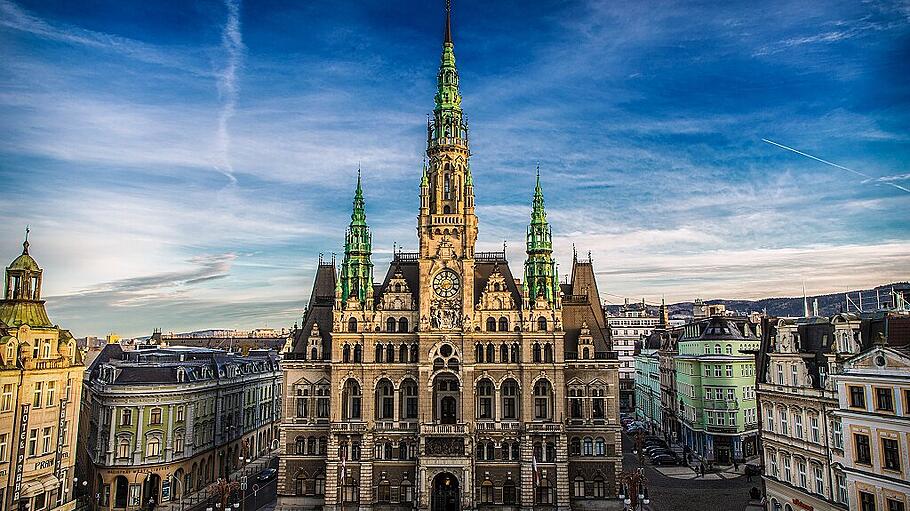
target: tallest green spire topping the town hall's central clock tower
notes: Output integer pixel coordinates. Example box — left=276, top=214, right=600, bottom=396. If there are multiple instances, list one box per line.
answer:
left=433, top=1, right=463, bottom=144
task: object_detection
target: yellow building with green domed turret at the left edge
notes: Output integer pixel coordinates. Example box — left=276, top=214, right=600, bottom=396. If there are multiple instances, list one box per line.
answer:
left=0, top=239, right=85, bottom=511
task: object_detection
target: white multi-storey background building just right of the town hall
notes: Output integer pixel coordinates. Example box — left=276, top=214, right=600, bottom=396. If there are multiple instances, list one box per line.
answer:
left=607, top=299, right=660, bottom=413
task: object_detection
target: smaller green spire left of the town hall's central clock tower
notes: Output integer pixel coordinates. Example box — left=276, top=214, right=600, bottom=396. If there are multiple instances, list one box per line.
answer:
left=341, top=168, right=373, bottom=303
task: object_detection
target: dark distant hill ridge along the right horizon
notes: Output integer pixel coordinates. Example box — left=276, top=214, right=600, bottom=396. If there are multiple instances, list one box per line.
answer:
left=670, top=282, right=910, bottom=317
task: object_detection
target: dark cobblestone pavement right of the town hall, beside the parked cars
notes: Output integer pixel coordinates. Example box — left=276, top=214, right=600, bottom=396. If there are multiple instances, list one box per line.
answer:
left=623, top=435, right=762, bottom=511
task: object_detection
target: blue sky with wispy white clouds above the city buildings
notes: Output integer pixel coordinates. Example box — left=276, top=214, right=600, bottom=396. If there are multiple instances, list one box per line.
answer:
left=0, top=0, right=910, bottom=335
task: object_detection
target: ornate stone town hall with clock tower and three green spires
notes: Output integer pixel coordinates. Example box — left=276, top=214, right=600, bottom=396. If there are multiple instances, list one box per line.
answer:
left=278, top=8, right=622, bottom=511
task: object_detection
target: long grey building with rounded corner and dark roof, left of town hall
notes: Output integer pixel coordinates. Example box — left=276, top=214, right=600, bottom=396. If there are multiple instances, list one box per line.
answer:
left=80, top=344, right=282, bottom=510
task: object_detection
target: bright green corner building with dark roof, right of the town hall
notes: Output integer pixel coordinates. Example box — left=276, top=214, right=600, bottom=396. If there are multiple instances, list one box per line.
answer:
left=675, top=316, right=761, bottom=463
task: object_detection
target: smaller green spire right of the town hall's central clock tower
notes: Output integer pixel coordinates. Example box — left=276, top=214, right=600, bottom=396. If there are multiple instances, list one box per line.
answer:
left=525, top=164, right=559, bottom=305
